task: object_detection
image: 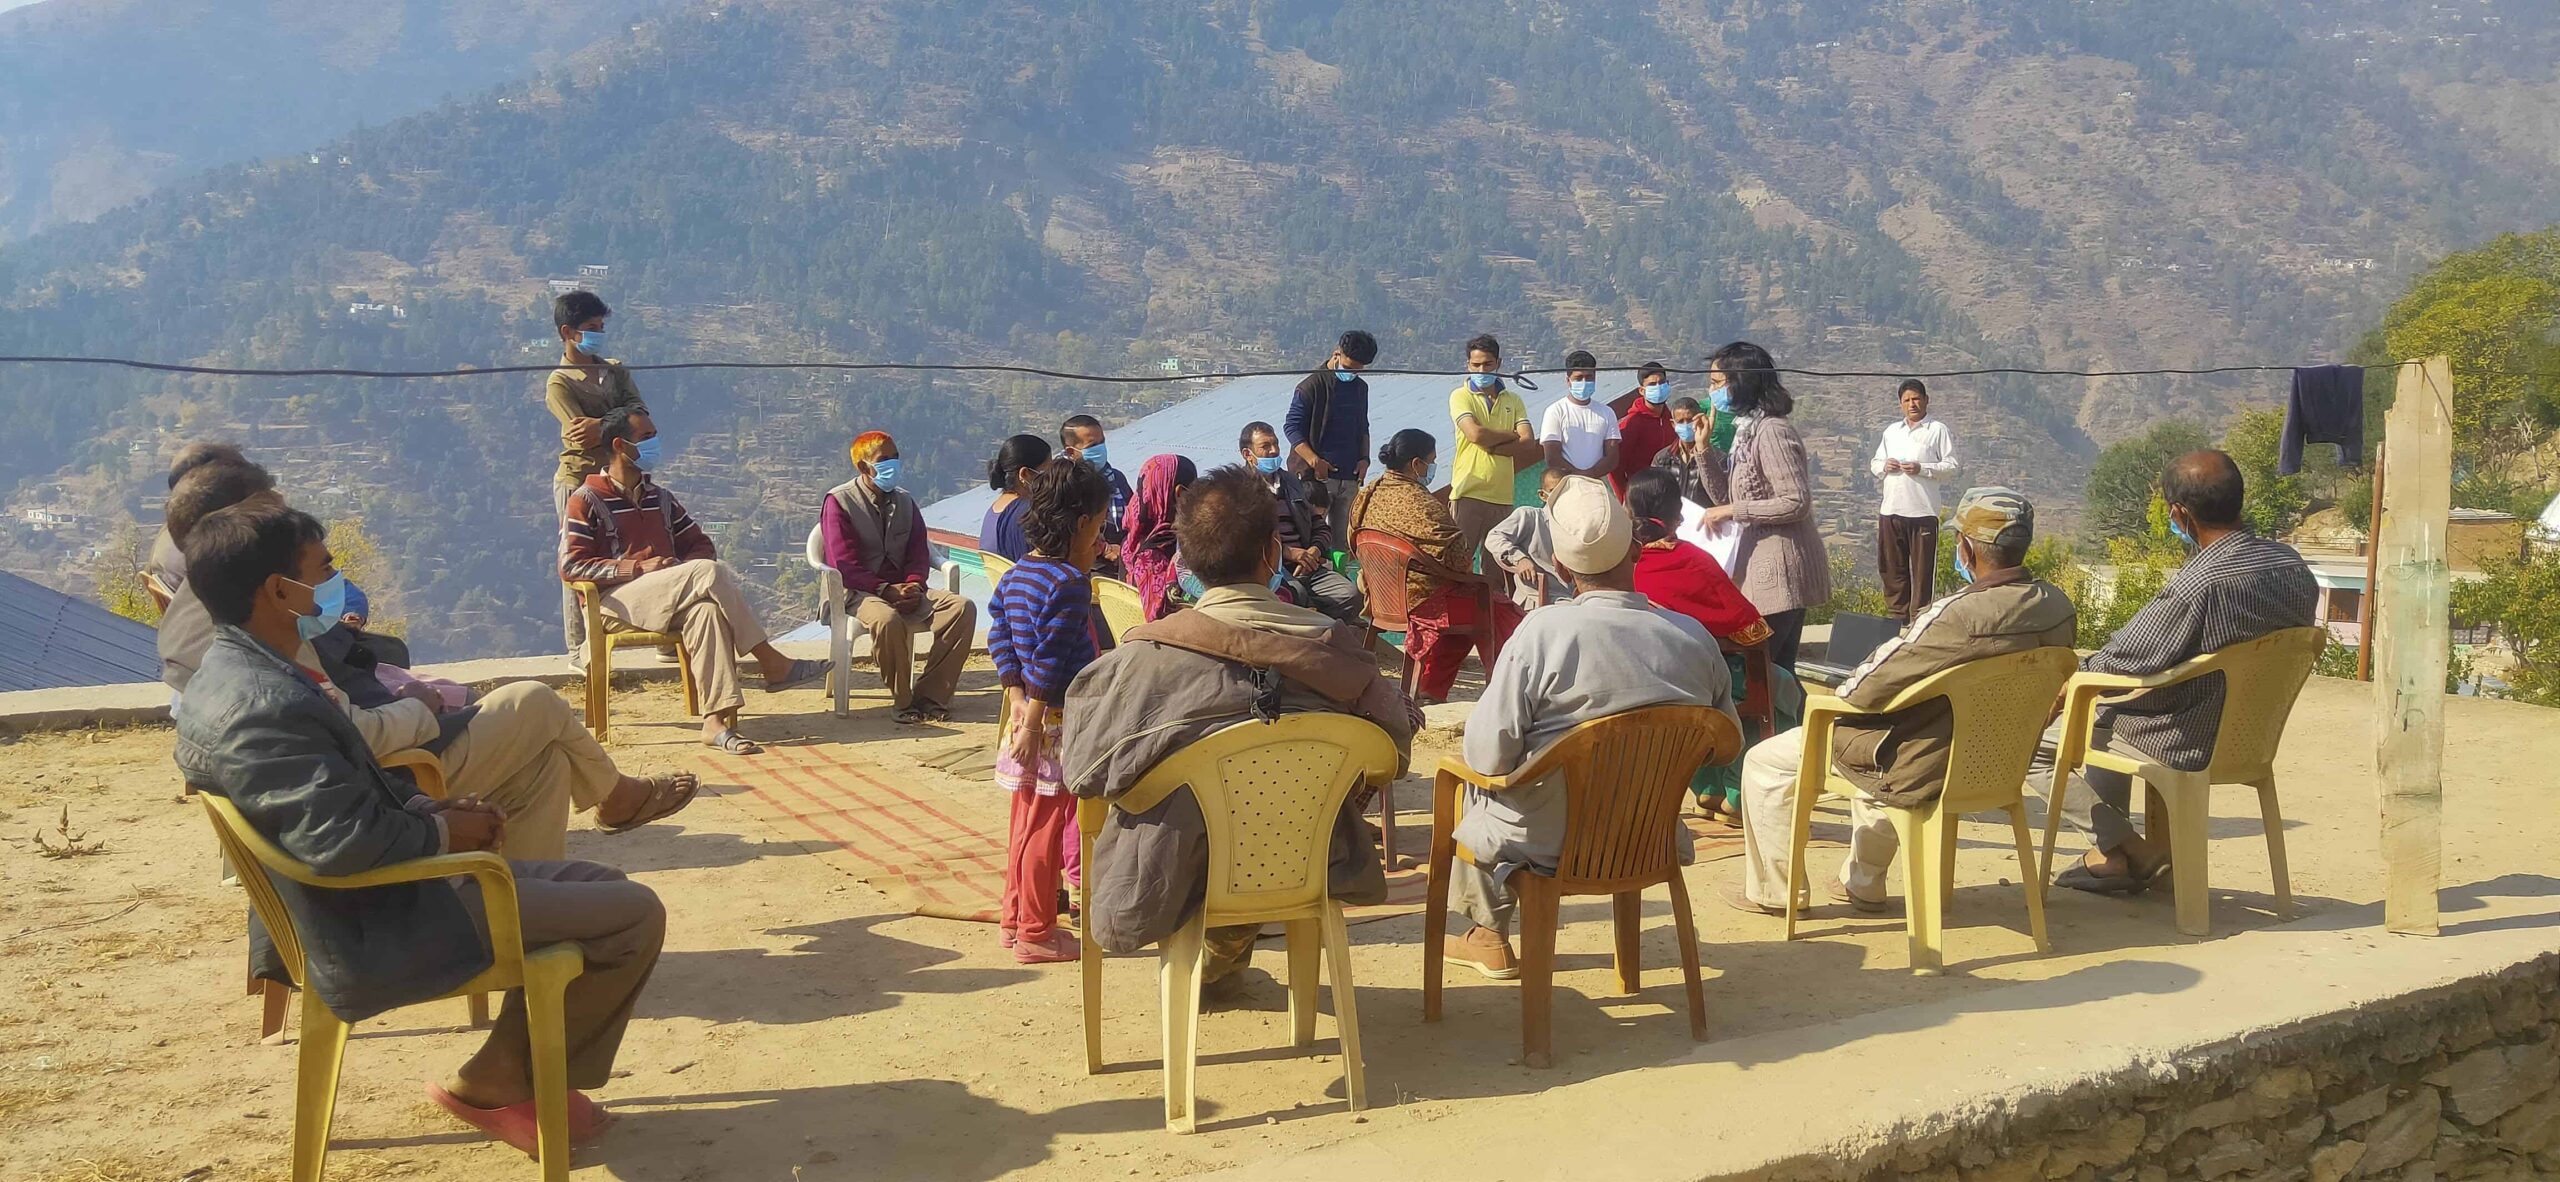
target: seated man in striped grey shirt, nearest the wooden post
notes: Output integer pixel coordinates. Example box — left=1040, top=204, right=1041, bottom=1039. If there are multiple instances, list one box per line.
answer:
left=2028, top=450, right=2319, bottom=895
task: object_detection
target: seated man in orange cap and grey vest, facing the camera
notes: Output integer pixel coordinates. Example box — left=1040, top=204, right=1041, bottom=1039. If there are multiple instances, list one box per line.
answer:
left=819, top=430, right=978, bottom=724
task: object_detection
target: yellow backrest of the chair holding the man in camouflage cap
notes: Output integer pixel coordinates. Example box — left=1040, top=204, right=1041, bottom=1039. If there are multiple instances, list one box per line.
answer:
left=1879, top=645, right=2079, bottom=814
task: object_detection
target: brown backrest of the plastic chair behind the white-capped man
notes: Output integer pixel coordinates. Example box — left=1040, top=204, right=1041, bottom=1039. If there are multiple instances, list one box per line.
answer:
left=1508, top=706, right=1741, bottom=883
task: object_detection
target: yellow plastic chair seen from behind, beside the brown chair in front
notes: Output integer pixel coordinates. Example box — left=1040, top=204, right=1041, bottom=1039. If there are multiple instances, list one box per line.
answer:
left=1075, top=714, right=1395, bottom=1133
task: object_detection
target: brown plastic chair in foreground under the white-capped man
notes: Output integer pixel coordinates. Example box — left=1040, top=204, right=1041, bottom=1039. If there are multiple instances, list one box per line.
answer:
left=1423, top=706, right=1741, bottom=1067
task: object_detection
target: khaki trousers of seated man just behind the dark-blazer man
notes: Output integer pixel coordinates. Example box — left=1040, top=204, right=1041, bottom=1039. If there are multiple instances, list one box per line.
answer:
left=440, top=681, right=622, bottom=862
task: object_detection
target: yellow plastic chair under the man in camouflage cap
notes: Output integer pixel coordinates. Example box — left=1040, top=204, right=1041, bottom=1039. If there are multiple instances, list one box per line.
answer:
left=1787, top=647, right=2079, bottom=977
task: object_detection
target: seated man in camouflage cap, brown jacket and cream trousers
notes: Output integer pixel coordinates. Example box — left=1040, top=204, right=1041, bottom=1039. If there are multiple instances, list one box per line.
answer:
left=1725, top=486, right=2079, bottom=916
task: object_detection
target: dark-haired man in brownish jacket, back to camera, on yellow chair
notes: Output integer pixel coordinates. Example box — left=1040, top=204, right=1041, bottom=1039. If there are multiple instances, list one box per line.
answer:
left=1060, top=468, right=1421, bottom=985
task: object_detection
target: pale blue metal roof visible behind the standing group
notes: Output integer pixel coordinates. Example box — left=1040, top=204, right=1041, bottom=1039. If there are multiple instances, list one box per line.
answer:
left=924, top=368, right=1636, bottom=537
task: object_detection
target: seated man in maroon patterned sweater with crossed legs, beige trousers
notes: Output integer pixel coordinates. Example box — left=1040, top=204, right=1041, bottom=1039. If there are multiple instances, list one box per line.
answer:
left=561, top=409, right=827, bottom=755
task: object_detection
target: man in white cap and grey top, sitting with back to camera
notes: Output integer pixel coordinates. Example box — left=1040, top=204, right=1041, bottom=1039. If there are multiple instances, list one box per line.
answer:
left=1444, top=476, right=1733, bottom=980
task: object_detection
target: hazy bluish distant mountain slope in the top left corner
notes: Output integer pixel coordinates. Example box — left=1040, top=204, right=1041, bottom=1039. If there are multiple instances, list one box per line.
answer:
left=0, top=0, right=668, bottom=243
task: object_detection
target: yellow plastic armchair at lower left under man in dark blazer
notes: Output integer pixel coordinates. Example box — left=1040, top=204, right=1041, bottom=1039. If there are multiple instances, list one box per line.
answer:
left=197, top=791, right=586, bottom=1182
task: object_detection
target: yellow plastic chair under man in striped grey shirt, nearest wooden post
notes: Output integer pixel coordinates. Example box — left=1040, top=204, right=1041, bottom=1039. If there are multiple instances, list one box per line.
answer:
left=2035, top=627, right=2330, bottom=936
